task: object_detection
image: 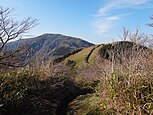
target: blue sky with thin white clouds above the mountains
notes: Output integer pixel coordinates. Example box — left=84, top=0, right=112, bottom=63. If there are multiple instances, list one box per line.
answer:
left=0, top=0, right=153, bottom=43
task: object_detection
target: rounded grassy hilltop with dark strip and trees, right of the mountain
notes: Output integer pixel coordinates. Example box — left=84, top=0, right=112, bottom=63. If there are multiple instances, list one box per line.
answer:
left=64, top=41, right=152, bottom=66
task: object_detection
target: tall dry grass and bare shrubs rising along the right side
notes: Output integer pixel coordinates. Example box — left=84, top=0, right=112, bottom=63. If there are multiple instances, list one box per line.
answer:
left=97, top=41, right=153, bottom=115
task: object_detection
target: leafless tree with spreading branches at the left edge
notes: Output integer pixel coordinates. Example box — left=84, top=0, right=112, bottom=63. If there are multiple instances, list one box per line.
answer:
left=0, top=7, right=37, bottom=66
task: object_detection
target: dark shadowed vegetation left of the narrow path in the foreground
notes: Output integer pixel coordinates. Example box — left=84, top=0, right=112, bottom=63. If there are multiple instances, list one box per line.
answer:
left=0, top=68, right=94, bottom=115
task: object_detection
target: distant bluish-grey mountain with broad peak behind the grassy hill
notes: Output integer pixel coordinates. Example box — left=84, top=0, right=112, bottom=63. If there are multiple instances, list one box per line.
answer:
left=7, top=34, right=93, bottom=61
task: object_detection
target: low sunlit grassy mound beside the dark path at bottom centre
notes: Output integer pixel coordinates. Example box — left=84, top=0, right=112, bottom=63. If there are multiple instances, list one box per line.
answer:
left=67, top=94, right=102, bottom=115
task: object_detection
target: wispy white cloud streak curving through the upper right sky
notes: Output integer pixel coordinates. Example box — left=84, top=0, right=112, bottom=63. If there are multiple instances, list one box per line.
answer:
left=94, top=0, right=151, bottom=34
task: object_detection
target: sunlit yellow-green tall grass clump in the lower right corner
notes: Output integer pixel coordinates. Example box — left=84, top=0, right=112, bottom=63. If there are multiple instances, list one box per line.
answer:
left=101, top=73, right=153, bottom=115
